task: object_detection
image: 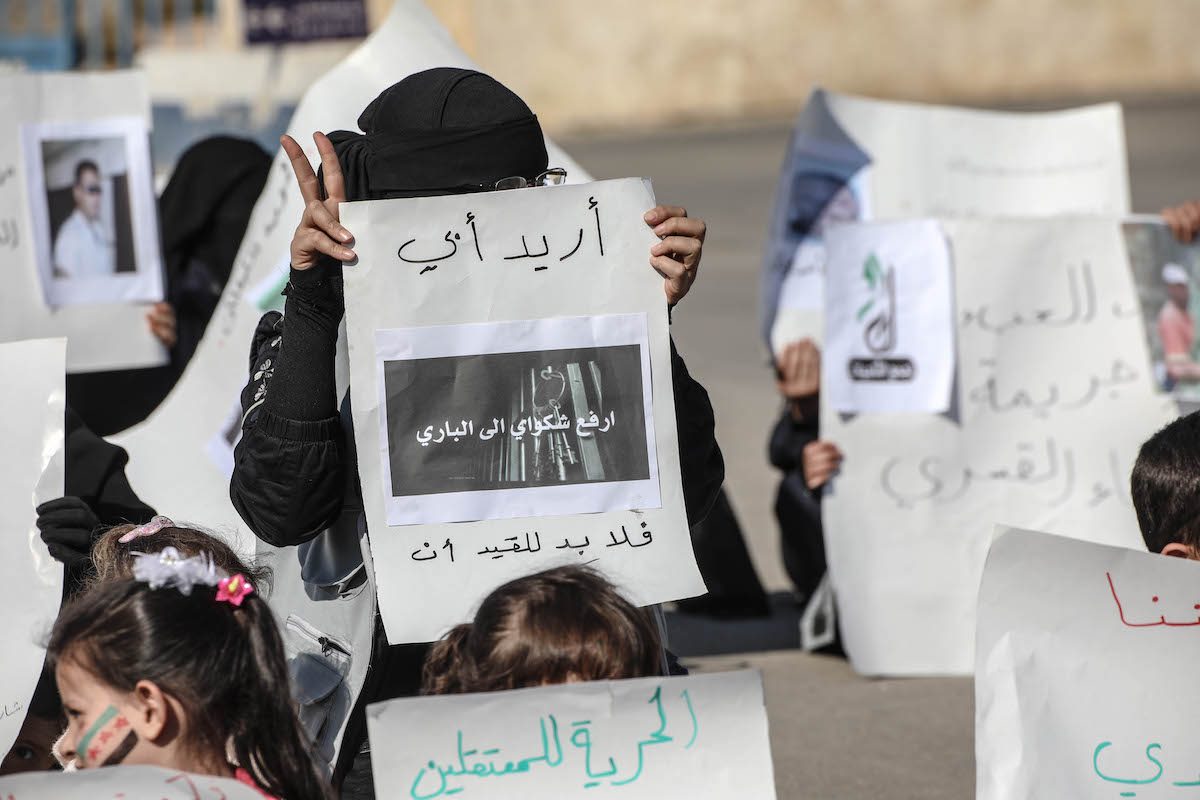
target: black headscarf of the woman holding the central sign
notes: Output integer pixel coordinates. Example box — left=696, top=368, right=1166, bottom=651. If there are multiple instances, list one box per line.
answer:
left=322, top=67, right=547, bottom=200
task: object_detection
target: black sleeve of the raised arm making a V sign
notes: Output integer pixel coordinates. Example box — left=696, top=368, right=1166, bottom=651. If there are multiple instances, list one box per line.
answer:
left=229, top=266, right=346, bottom=547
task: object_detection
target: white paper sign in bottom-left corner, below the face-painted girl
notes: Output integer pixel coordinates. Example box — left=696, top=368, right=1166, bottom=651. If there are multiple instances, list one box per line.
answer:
left=0, top=766, right=263, bottom=800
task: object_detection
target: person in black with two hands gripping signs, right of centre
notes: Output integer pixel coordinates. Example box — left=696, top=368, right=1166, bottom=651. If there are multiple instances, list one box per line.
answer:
left=769, top=339, right=841, bottom=623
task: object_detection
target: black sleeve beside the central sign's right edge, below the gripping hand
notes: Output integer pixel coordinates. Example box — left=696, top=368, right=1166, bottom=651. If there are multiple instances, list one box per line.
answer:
left=671, top=339, right=725, bottom=527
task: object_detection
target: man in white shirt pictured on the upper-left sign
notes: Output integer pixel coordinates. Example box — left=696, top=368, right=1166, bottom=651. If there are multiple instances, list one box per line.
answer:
left=53, top=158, right=116, bottom=278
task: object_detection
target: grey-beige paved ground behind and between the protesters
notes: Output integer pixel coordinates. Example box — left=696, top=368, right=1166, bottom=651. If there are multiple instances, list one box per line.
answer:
left=560, top=96, right=1200, bottom=800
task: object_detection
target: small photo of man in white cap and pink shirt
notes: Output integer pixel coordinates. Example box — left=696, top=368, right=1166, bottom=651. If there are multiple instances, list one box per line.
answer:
left=1123, top=222, right=1200, bottom=410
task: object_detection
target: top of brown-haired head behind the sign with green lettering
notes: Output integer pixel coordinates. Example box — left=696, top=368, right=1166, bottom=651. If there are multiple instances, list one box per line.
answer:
left=421, top=566, right=662, bottom=694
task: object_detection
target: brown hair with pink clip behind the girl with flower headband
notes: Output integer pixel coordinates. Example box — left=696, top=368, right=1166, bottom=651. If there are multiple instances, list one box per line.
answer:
left=89, top=517, right=271, bottom=593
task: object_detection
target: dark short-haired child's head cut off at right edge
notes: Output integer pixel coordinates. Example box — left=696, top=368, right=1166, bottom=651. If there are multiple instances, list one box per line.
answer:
left=1129, top=411, right=1200, bottom=559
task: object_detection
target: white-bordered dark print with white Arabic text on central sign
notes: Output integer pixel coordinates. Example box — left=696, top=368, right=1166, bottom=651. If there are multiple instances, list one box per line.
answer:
left=379, top=315, right=656, bottom=524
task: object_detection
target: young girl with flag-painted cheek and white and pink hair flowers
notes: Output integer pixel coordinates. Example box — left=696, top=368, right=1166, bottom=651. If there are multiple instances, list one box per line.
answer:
left=47, top=547, right=330, bottom=800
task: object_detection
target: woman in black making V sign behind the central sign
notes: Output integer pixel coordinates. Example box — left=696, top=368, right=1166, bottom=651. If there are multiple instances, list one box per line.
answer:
left=230, top=68, right=725, bottom=796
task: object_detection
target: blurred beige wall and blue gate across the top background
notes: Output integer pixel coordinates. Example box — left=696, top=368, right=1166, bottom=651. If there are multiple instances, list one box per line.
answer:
left=0, top=0, right=1200, bottom=162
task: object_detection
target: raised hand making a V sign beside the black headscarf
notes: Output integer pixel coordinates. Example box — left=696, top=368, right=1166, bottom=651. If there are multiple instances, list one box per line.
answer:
left=280, top=131, right=355, bottom=270
